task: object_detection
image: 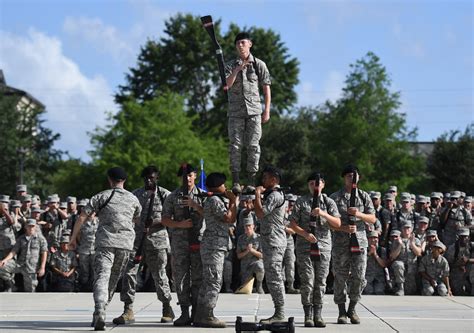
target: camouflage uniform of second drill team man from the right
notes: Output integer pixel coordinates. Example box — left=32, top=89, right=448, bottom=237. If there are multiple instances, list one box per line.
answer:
left=290, top=193, right=340, bottom=306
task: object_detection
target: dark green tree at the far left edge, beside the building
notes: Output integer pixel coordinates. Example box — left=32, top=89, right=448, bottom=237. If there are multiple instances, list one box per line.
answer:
left=0, top=93, right=62, bottom=196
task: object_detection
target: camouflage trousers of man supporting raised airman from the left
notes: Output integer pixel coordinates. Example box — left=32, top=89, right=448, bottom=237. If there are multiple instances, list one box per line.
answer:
left=198, top=247, right=227, bottom=309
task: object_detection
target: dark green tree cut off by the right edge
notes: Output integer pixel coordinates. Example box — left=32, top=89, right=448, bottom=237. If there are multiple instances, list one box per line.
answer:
left=428, top=123, right=474, bottom=193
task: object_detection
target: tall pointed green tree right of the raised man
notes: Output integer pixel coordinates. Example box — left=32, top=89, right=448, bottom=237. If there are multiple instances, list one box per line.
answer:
left=314, top=52, right=423, bottom=190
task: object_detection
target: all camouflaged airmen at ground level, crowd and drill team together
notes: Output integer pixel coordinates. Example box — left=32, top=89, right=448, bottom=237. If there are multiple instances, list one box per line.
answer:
left=0, top=164, right=474, bottom=329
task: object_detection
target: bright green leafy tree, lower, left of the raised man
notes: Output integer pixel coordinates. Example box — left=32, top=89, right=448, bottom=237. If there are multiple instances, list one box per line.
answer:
left=91, top=94, right=229, bottom=188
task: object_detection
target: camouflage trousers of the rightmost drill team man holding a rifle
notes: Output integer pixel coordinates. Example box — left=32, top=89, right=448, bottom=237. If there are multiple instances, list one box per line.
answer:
left=332, top=245, right=367, bottom=304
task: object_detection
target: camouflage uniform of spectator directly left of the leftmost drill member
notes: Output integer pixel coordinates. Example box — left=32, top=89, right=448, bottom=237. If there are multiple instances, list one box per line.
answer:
left=76, top=217, right=99, bottom=289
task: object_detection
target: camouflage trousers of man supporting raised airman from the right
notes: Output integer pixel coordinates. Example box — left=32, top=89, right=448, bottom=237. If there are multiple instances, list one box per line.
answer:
left=262, top=243, right=285, bottom=306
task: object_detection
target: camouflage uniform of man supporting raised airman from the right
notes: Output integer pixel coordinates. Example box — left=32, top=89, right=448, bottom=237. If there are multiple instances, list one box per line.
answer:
left=260, top=191, right=286, bottom=307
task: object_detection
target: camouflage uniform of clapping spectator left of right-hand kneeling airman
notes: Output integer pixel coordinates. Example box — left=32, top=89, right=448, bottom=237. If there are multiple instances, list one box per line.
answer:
left=390, top=238, right=426, bottom=295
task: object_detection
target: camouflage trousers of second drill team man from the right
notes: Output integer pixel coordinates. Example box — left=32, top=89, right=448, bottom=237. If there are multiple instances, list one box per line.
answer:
left=296, top=251, right=331, bottom=306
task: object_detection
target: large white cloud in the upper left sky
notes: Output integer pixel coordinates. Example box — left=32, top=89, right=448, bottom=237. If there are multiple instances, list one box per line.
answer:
left=0, top=29, right=116, bottom=160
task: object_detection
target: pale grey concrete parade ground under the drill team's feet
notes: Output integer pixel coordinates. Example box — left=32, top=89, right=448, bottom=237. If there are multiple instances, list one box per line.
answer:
left=0, top=293, right=474, bottom=333
